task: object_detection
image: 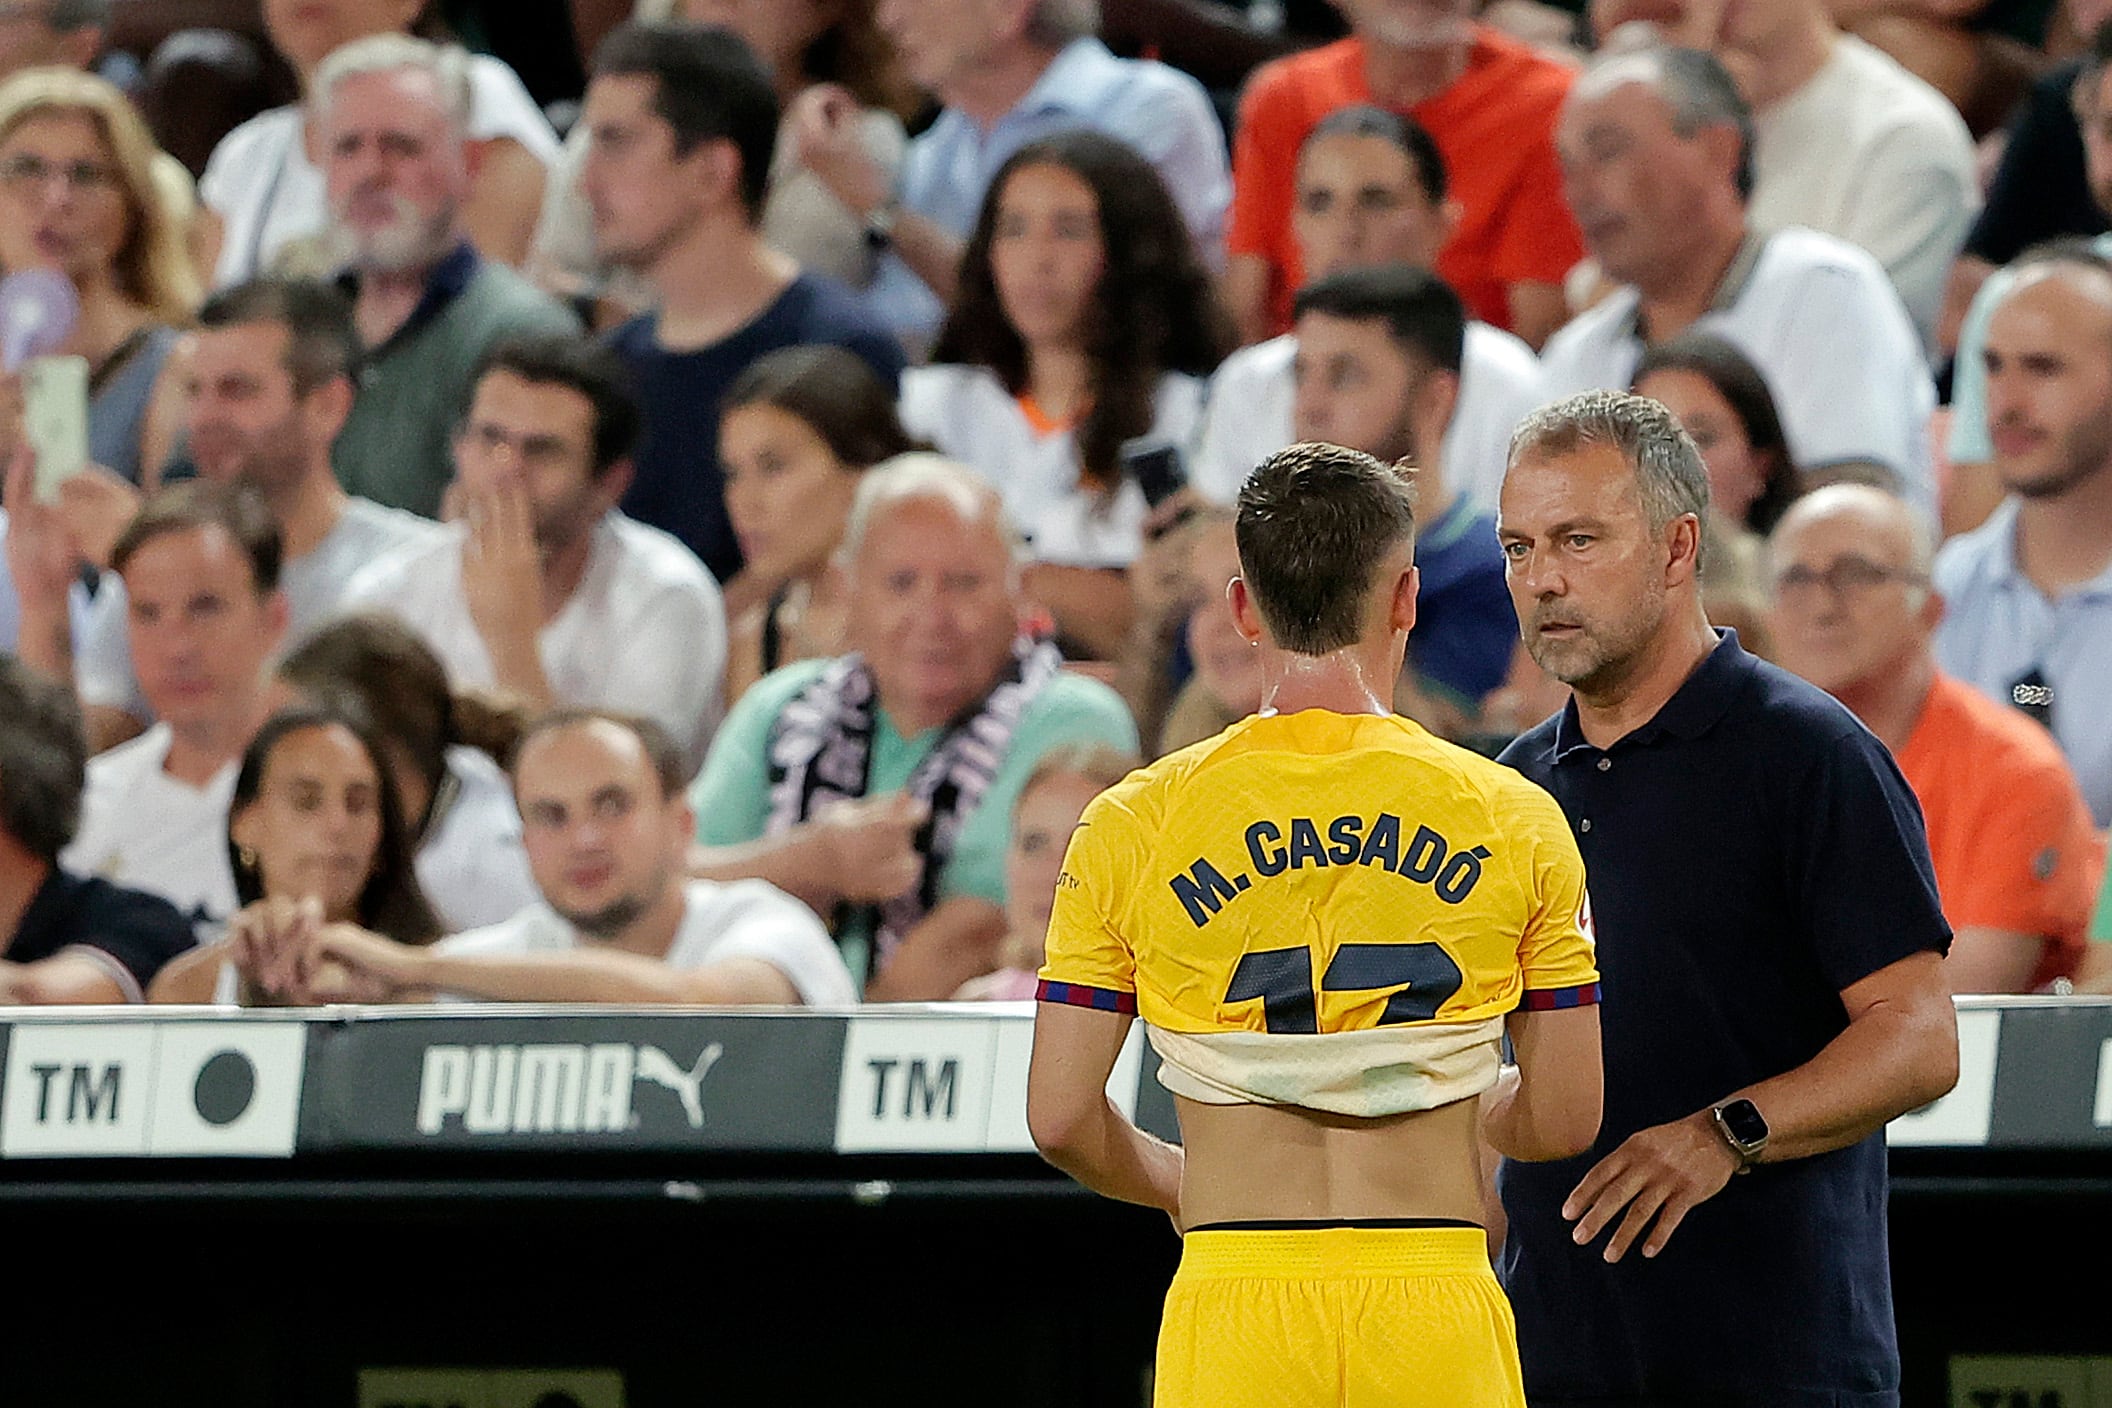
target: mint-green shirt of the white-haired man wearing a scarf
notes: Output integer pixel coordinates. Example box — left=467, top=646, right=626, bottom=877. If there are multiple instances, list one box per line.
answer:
left=689, top=661, right=1136, bottom=987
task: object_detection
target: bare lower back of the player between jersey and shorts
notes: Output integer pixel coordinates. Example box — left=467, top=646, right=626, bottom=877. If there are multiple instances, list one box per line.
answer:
left=1174, top=1100, right=1483, bottom=1226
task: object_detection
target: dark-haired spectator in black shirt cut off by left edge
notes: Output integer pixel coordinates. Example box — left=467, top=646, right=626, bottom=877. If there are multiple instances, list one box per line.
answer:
left=0, top=654, right=192, bottom=1007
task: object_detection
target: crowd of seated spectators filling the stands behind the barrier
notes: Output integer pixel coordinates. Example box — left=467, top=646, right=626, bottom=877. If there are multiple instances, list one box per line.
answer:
left=0, top=0, right=2112, bottom=1005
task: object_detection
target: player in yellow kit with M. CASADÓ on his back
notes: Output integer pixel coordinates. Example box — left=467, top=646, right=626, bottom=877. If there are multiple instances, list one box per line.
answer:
left=1026, top=443, right=1601, bottom=1408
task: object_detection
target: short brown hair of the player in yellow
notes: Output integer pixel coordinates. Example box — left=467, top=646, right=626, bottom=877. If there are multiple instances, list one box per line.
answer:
left=1233, top=441, right=1415, bottom=654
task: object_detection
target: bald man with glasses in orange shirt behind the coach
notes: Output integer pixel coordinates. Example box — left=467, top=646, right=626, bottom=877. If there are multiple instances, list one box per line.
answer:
left=1770, top=483, right=2104, bottom=992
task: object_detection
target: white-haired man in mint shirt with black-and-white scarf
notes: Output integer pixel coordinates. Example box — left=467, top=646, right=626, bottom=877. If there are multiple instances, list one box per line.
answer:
left=691, top=454, right=1136, bottom=1001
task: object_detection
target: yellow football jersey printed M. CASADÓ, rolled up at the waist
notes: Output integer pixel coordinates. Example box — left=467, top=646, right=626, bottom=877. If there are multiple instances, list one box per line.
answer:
left=1039, top=709, right=1599, bottom=1115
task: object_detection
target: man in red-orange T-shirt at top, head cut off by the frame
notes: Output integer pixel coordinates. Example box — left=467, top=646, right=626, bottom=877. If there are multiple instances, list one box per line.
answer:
left=1225, top=0, right=1584, bottom=346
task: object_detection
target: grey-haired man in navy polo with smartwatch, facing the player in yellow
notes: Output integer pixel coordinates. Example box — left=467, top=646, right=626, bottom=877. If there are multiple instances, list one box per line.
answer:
left=1497, top=393, right=1958, bottom=1408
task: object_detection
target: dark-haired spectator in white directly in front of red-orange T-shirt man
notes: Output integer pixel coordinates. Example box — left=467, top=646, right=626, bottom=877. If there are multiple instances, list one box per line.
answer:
left=1193, top=106, right=1540, bottom=513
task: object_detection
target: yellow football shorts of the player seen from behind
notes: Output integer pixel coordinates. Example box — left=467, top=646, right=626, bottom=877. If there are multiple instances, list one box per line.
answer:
left=1153, top=1224, right=1525, bottom=1408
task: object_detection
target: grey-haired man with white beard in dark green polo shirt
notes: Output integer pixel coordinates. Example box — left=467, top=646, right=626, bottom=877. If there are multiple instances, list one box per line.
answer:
left=310, top=34, right=579, bottom=517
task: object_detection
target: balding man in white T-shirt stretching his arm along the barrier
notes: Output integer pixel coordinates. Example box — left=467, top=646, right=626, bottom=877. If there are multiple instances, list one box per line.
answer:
left=293, top=711, right=853, bottom=1007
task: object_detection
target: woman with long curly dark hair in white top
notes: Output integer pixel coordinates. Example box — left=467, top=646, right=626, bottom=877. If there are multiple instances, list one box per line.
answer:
left=902, top=131, right=1233, bottom=659
